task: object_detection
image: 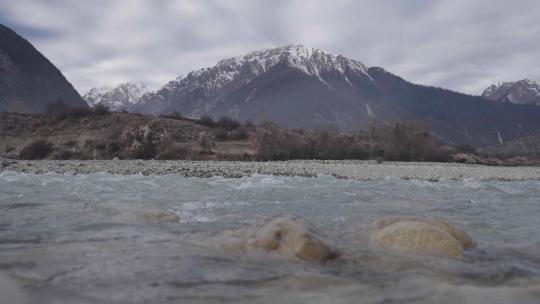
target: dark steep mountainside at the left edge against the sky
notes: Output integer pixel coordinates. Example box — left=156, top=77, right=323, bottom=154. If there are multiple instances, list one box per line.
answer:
left=0, top=25, right=88, bottom=113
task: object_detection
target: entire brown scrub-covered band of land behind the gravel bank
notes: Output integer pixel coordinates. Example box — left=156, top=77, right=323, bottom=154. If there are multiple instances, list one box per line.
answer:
left=4, top=107, right=540, bottom=166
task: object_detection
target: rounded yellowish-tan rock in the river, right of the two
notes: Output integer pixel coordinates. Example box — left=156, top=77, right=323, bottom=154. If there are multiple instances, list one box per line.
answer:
left=370, top=218, right=476, bottom=258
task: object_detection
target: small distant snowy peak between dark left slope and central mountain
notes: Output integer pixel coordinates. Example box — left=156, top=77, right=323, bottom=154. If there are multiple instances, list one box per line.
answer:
left=83, top=83, right=148, bottom=111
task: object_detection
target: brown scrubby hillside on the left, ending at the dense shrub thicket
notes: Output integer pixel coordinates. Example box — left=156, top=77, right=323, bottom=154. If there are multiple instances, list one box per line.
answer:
left=0, top=110, right=249, bottom=160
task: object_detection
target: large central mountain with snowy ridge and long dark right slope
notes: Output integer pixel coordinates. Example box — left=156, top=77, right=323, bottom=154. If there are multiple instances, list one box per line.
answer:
left=133, top=45, right=540, bottom=146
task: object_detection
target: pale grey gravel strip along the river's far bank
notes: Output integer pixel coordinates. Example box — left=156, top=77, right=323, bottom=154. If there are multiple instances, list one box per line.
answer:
left=0, top=159, right=540, bottom=181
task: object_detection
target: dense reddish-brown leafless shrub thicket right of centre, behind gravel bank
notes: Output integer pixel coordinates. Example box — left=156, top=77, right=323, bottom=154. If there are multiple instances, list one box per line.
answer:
left=250, top=122, right=450, bottom=161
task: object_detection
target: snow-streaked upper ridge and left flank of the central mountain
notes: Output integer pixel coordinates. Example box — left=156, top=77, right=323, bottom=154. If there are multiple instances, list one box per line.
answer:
left=134, top=45, right=373, bottom=118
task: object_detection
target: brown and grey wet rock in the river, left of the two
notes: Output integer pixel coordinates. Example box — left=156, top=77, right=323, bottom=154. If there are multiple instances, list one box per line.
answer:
left=218, top=216, right=339, bottom=263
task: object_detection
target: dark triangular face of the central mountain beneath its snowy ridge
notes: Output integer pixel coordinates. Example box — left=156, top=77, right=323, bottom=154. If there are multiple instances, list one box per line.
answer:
left=209, top=64, right=367, bottom=129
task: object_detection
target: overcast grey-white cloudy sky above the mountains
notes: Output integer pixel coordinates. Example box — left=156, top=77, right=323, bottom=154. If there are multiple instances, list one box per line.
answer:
left=0, top=0, right=540, bottom=94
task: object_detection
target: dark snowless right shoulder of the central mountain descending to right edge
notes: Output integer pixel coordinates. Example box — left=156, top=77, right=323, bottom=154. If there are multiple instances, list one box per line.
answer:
left=360, top=68, right=540, bottom=146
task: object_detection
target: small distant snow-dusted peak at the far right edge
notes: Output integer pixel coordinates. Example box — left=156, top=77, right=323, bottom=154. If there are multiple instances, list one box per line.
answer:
left=482, top=79, right=540, bottom=105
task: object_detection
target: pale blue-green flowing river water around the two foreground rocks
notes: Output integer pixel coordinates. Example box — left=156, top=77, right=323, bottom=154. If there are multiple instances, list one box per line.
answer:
left=0, top=172, right=540, bottom=303
